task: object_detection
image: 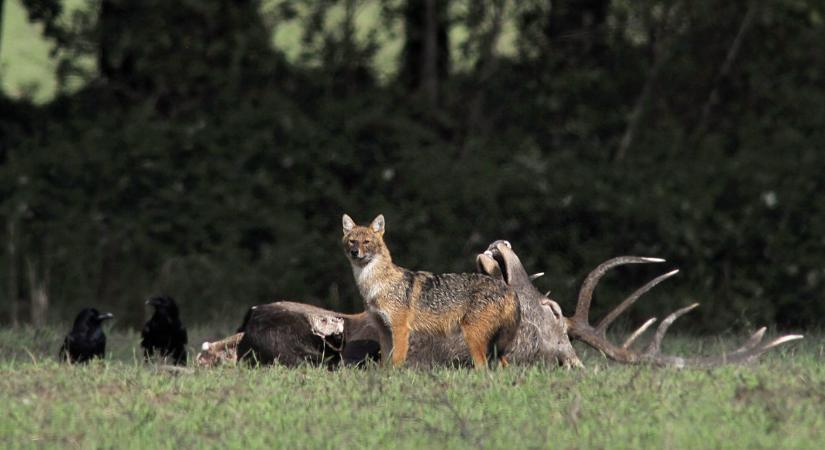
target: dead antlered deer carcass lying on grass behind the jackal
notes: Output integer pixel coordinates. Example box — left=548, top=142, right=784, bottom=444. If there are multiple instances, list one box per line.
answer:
left=198, top=241, right=802, bottom=367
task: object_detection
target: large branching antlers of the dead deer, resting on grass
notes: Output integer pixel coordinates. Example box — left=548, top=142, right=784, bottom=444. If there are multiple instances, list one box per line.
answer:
left=567, top=256, right=802, bottom=367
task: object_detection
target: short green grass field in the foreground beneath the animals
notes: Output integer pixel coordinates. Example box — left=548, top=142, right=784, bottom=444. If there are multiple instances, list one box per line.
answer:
left=0, top=329, right=825, bottom=449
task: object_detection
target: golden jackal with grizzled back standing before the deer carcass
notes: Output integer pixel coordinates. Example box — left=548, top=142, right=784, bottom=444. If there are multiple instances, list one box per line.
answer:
left=342, top=214, right=520, bottom=368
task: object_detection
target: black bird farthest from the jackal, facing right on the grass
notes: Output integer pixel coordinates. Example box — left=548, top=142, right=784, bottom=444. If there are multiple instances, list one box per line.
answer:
left=58, top=308, right=114, bottom=363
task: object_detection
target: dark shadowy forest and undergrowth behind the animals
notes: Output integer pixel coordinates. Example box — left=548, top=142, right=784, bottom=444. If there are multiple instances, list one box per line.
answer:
left=0, top=0, right=825, bottom=332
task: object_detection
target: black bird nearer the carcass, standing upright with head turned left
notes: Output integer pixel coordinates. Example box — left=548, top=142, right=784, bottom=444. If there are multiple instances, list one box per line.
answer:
left=140, top=295, right=186, bottom=365
